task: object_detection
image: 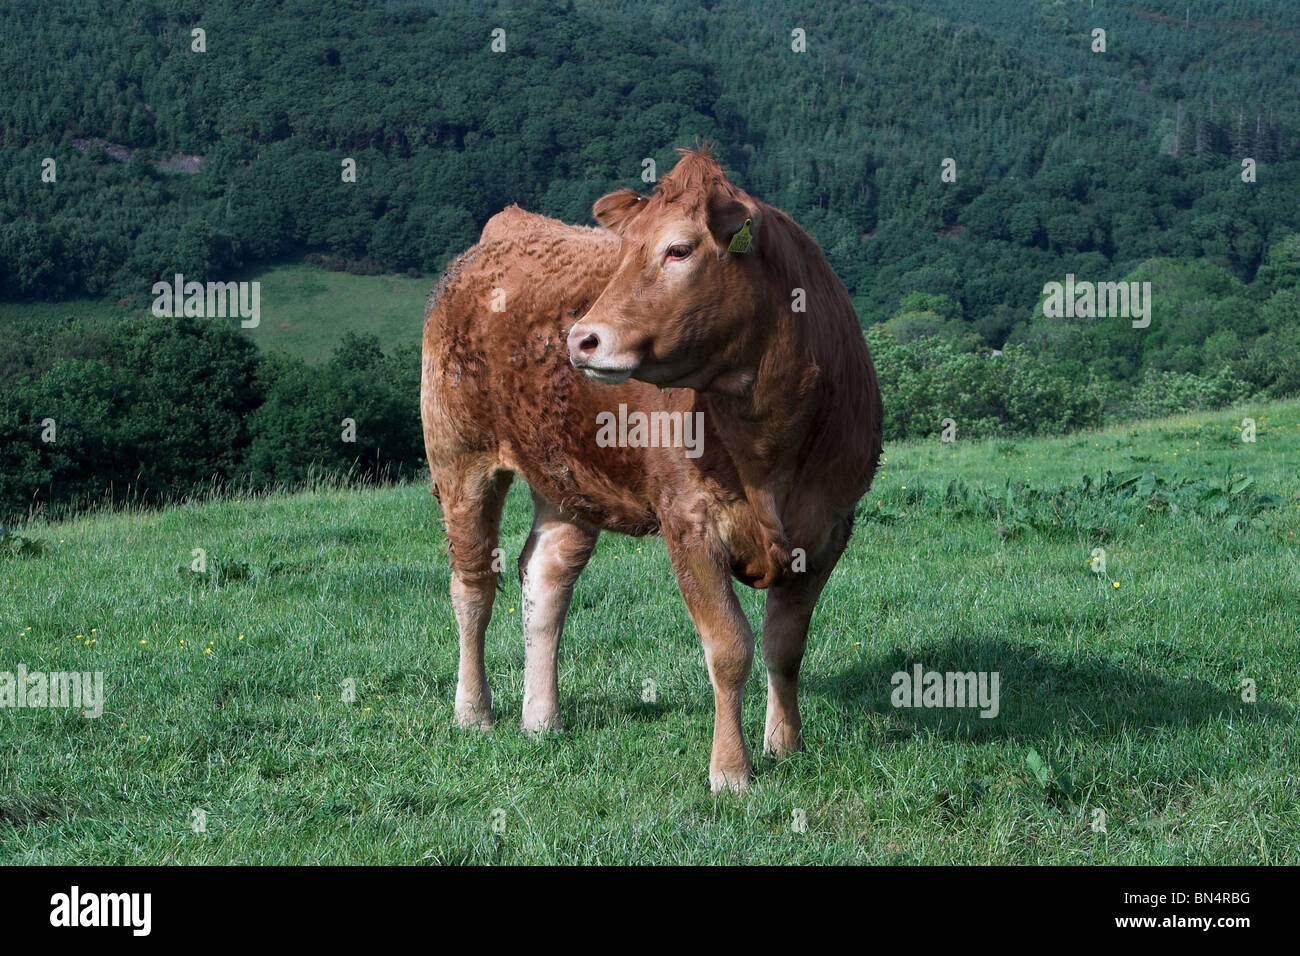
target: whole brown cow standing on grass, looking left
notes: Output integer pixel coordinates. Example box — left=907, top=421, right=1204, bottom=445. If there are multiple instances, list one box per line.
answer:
left=420, top=151, right=883, bottom=791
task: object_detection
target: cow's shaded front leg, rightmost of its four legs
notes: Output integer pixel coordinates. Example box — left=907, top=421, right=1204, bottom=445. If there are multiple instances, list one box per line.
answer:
left=762, top=518, right=853, bottom=757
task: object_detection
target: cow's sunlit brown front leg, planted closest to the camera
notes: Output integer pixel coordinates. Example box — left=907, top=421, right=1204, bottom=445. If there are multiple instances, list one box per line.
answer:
left=664, top=515, right=754, bottom=793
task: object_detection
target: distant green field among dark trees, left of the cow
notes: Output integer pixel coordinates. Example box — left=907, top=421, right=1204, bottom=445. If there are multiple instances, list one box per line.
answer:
left=0, top=263, right=433, bottom=363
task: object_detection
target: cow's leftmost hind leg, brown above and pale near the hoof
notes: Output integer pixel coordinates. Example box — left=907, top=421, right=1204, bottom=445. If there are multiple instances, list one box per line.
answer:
left=434, top=462, right=514, bottom=730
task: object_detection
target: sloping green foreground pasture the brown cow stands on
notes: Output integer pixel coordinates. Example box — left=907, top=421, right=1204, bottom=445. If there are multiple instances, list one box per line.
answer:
left=0, top=400, right=1300, bottom=864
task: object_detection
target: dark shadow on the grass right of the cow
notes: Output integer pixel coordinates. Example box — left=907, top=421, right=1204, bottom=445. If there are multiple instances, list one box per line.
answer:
left=801, top=637, right=1294, bottom=740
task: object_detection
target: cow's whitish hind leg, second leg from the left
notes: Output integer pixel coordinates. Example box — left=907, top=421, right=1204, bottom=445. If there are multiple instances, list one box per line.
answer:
left=519, top=493, right=599, bottom=734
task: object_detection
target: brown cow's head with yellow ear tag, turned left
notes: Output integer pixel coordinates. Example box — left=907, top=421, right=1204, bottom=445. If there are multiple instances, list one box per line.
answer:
left=568, top=151, right=764, bottom=390
